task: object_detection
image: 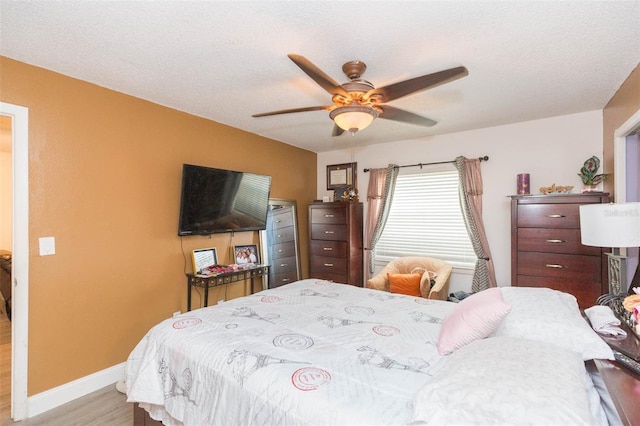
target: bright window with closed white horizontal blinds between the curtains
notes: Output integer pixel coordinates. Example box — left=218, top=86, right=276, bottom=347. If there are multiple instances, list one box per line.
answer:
left=376, top=167, right=477, bottom=269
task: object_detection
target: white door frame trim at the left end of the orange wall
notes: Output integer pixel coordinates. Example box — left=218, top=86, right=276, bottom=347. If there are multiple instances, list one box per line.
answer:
left=0, top=102, right=29, bottom=421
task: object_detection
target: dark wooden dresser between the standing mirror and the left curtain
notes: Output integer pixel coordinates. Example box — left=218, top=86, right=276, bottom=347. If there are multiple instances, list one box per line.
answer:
left=309, top=202, right=363, bottom=287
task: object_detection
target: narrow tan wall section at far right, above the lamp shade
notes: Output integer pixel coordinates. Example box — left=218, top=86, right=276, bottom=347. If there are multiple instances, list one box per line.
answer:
left=602, top=64, right=640, bottom=197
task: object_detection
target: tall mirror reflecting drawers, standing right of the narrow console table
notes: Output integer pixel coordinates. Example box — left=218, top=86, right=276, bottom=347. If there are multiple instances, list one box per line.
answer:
left=267, top=205, right=300, bottom=288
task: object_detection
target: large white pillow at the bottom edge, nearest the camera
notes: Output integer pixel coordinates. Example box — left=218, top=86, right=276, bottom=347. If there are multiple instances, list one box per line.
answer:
left=410, top=337, right=594, bottom=425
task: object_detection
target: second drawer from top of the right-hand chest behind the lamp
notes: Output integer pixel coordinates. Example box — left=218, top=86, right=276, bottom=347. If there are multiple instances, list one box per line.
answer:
left=518, top=228, right=600, bottom=256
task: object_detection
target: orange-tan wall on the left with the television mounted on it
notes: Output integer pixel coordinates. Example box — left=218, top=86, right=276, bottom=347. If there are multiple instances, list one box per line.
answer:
left=0, top=58, right=316, bottom=395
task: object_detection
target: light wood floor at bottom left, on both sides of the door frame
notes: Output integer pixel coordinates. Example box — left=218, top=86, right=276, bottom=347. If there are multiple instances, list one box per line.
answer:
left=0, top=315, right=133, bottom=426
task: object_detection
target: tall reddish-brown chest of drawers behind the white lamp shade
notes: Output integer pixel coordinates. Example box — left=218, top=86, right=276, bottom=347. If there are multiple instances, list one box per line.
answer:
left=511, top=193, right=609, bottom=309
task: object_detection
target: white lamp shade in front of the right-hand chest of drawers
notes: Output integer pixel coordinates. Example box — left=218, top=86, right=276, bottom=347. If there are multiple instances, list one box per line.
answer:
left=580, top=203, right=640, bottom=248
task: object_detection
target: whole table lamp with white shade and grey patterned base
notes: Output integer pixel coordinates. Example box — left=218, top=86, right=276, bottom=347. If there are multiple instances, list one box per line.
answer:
left=580, top=203, right=640, bottom=295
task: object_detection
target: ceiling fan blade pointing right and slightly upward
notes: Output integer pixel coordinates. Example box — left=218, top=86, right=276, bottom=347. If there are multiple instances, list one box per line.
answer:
left=364, top=67, right=469, bottom=103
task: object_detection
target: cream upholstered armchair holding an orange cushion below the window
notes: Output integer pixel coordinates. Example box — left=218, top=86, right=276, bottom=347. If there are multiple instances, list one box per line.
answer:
left=367, top=256, right=452, bottom=300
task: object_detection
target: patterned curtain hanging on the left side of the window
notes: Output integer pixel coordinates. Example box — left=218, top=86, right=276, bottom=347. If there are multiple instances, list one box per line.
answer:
left=366, top=164, right=398, bottom=279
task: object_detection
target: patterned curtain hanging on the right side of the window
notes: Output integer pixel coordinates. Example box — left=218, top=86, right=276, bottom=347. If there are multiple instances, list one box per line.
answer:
left=456, top=156, right=497, bottom=293
